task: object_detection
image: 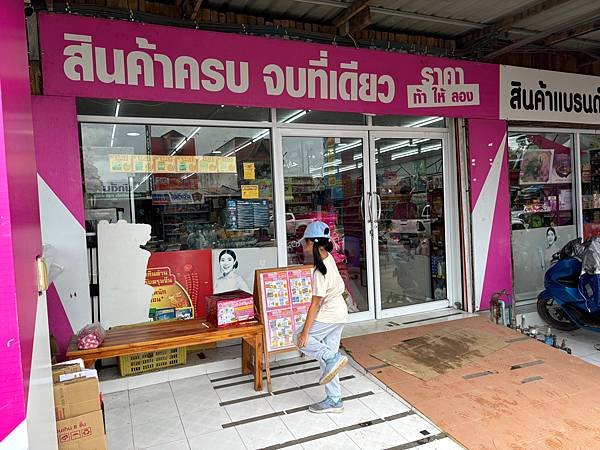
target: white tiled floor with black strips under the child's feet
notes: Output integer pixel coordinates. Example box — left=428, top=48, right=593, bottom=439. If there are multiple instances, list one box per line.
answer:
left=104, top=358, right=462, bottom=450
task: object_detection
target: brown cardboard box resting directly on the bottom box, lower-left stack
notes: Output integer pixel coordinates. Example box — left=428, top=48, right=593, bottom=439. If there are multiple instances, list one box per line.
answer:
left=54, top=378, right=100, bottom=420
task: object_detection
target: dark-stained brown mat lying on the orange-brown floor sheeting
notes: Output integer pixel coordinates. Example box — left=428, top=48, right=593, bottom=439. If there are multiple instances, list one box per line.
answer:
left=373, top=328, right=508, bottom=380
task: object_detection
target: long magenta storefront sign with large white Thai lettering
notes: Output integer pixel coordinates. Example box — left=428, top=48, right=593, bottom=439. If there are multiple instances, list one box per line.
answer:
left=40, top=14, right=499, bottom=119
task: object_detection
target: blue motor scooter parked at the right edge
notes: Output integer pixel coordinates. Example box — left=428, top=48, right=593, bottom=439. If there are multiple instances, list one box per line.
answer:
left=537, top=238, right=600, bottom=332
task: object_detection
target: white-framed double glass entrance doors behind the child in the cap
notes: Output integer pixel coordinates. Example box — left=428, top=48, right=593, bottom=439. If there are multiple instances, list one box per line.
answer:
left=280, top=130, right=459, bottom=320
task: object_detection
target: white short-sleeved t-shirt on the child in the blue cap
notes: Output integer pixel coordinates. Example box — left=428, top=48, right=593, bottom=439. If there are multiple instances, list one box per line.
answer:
left=313, top=255, right=348, bottom=323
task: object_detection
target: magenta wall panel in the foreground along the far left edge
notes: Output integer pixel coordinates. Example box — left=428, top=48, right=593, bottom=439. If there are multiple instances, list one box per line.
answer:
left=0, top=0, right=41, bottom=440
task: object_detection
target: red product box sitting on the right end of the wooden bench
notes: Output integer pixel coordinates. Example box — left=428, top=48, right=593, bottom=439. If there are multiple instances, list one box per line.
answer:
left=206, top=291, right=254, bottom=327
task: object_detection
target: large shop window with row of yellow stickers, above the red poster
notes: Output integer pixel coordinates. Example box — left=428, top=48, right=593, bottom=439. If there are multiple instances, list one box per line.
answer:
left=81, top=123, right=276, bottom=251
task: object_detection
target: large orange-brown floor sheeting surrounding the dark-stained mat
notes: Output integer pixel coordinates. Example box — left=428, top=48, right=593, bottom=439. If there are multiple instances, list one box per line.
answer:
left=342, top=317, right=600, bottom=450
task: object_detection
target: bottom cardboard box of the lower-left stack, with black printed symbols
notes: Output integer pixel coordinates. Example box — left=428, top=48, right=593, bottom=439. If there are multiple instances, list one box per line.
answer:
left=56, top=411, right=107, bottom=450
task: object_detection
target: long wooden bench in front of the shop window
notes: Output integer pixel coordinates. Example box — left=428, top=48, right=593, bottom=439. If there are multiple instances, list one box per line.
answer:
left=67, top=319, right=263, bottom=391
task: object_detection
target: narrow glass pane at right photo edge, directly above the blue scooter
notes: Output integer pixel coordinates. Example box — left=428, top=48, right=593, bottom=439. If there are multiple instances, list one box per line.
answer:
left=579, top=134, right=600, bottom=239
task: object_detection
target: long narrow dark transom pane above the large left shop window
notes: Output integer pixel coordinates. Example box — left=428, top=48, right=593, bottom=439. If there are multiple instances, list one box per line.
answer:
left=77, top=98, right=270, bottom=122
